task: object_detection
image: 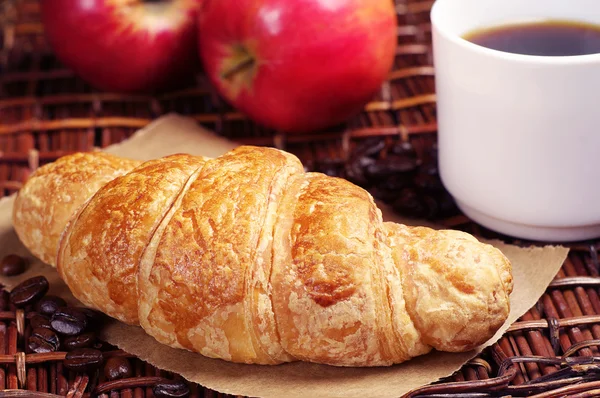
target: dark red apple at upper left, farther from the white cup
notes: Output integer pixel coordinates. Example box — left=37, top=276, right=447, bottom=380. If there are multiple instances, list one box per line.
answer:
left=41, top=0, right=199, bottom=92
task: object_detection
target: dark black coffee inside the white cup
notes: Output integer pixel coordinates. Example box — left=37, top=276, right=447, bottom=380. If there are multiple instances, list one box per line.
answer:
left=463, top=20, right=600, bottom=56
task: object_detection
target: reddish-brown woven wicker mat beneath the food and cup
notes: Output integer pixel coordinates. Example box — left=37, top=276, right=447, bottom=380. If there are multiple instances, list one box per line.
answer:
left=0, top=0, right=600, bottom=397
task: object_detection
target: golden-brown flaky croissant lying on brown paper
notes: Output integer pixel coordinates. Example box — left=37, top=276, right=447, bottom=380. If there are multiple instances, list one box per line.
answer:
left=13, top=146, right=513, bottom=366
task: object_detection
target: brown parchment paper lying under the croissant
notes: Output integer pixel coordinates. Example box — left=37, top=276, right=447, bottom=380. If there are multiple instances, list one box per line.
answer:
left=0, top=115, right=568, bottom=398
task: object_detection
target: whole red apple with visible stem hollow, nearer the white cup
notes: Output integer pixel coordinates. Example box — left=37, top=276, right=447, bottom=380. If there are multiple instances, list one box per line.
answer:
left=198, top=0, right=397, bottom=132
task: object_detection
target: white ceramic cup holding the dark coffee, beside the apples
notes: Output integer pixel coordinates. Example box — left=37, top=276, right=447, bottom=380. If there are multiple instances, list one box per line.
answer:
left=431, top=0, right=600, bottom=241
